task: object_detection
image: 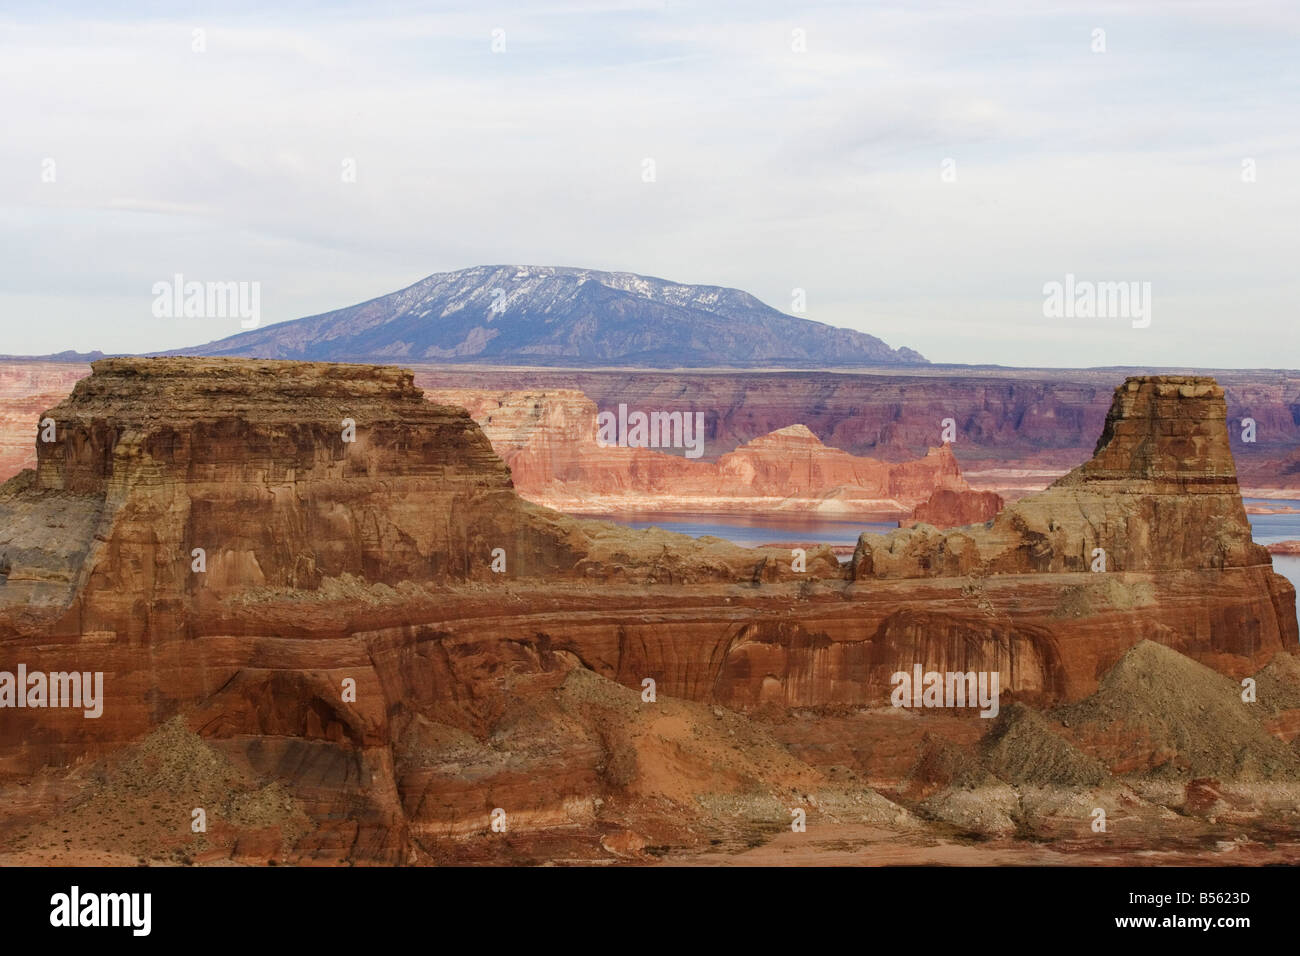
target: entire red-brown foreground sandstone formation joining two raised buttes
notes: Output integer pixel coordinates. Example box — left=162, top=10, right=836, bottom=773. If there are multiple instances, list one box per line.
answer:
left=0, top=359, right=1297, bottom=862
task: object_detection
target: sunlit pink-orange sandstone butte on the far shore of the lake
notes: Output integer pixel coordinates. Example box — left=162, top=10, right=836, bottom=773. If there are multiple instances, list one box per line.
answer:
left=425, top=389, right=1002, bottom=527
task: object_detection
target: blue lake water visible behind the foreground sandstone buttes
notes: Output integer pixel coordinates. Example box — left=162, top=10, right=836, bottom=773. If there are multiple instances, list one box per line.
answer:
left=589, top=498, right=1300, bottom=613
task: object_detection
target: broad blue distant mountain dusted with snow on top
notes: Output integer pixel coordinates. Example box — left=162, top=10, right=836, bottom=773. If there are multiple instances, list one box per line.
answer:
left=168, top=265, right=928, bottom=368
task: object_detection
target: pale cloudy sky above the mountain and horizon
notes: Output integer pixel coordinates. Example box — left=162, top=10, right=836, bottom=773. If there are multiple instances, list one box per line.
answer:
left=0, top=0, right=1300, bottom=368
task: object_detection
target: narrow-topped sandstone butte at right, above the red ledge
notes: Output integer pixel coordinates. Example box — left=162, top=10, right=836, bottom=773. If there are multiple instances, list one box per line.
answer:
left=854, top=376, right=1270, bottom=578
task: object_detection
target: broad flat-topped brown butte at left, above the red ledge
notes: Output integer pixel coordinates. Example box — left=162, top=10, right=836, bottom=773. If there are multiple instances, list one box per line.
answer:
left=0, top=359, right=566, bottom=637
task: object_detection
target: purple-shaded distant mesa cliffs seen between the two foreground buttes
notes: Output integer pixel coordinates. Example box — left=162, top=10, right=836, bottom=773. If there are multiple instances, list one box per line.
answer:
left=415, top=367, right=1112, bottom=471
